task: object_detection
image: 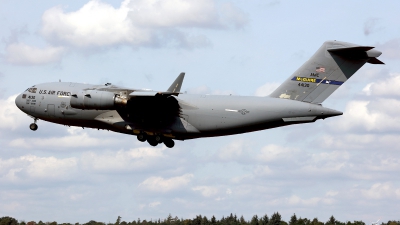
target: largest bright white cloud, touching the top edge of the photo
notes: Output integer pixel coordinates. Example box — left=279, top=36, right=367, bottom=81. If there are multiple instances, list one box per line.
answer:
left=41, top=0, right=247, bottom=48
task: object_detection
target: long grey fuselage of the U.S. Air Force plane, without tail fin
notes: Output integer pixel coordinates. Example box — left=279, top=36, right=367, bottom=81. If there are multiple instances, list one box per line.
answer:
left=16, top=82, right=342, bottom=143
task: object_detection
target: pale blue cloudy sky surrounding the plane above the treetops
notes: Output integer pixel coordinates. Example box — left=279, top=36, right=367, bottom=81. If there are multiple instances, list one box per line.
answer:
left=0, top=0, right=400, bottom=223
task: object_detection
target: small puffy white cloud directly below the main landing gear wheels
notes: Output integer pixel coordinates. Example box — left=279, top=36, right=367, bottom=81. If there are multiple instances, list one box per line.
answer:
left=139, top=174, right=194, bottom=192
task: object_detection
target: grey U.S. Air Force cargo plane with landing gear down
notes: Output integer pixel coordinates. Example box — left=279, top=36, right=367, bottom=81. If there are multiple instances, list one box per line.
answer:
left=15, top=40, right=384, bottom=148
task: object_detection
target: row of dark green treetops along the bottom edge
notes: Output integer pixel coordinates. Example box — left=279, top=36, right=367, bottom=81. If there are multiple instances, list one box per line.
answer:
left=0, top=212, right=400, bottom=225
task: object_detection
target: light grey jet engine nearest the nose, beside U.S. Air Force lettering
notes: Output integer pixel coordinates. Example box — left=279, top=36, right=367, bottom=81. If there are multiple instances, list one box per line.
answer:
left=70, top=90, right=127, bottom=110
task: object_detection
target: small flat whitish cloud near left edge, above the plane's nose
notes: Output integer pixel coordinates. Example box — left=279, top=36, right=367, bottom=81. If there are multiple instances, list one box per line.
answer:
left=6, top=43, right=65, bottom=65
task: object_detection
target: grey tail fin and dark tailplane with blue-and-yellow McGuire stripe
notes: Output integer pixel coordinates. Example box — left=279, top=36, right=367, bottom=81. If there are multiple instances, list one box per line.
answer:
left=270, top=41, right=384, bottom=104
